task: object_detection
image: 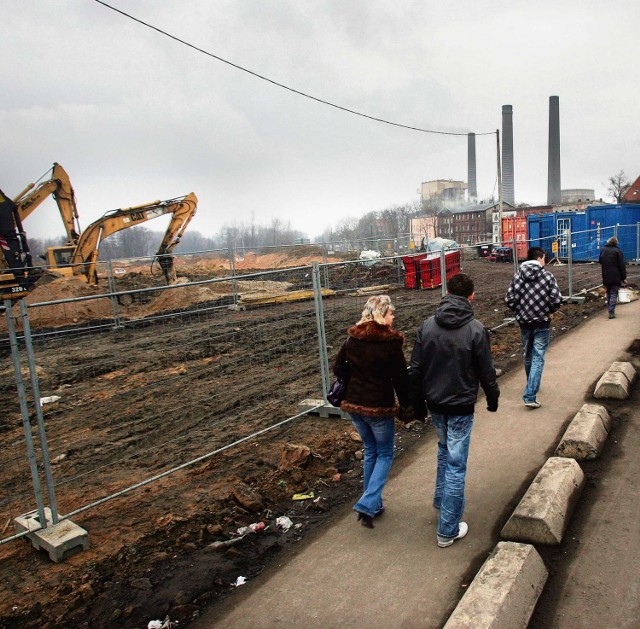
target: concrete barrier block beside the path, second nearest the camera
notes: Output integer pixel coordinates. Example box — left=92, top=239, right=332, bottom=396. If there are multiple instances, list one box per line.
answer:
left=500, top=457, right=584, bottom=545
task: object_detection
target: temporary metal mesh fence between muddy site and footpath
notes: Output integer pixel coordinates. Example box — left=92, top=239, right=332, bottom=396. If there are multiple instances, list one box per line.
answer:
left=0, top=225, right=638, bottom=541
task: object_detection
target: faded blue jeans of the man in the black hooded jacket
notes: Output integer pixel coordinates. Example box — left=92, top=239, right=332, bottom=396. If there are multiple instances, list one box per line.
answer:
left=431, top=411, right=473, bottom=538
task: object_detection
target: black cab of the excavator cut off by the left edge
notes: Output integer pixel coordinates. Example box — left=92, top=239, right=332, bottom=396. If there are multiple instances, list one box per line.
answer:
left=0, top=190, right=42, bottom=300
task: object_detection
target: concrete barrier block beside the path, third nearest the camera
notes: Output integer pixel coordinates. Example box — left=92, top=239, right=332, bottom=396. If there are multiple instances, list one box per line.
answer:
left=556, top=404, right=611, bottom=461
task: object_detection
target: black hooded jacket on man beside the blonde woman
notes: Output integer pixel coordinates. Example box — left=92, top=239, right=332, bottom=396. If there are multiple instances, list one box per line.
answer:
left=409, top=295, right=500, bottom=417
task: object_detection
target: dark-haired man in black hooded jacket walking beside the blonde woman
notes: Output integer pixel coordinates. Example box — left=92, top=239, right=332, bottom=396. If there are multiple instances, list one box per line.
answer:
left=409, top=273, right=500, bottom=548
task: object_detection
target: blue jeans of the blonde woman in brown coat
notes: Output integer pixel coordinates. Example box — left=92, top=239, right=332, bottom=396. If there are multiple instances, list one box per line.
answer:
left=350, top=413, right=395, bottom=517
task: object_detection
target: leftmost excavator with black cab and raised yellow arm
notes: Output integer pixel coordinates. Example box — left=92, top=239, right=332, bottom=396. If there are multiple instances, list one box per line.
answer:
left=0, top=163, right=80, bottom=299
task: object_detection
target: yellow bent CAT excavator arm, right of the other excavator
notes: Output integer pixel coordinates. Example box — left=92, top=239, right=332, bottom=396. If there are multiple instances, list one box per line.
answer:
left=69, top=192, right=198, bottom=284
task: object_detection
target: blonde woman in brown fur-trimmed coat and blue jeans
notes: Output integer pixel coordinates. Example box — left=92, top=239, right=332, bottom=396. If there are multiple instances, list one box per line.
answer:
left=333, top=295, right=413, bottom=528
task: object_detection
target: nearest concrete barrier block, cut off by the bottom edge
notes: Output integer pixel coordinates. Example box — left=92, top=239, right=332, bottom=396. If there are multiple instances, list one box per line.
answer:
left=444, top=542, right=548, bottom=629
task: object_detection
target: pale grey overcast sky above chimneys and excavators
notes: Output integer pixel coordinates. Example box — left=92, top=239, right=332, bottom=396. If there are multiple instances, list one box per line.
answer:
left=0, top=0, right=640, bottom=238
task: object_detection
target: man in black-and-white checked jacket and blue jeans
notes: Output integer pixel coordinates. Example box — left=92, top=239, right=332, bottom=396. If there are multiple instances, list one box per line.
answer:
left=504, top=247, right=562, bottom=408
